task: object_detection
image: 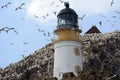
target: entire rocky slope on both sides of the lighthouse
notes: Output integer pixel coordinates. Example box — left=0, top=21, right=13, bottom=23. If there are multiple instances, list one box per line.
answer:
left=0, top=31, right=120, bottom=80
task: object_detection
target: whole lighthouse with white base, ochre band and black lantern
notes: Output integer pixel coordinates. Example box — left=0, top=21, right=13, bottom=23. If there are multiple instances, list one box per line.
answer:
left=53, top=2, right=83, bottom=80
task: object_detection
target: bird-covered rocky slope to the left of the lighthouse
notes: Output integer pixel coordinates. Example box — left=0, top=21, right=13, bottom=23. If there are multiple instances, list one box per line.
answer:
left=0, top=43, right=54, bottom=80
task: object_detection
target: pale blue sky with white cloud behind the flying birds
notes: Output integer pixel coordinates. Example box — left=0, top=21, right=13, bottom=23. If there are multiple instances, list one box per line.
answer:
left=0, top=0, right=120, bottom=68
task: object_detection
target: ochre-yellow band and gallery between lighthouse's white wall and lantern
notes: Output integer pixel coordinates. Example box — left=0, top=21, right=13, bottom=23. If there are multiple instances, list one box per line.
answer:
left=54, top=28, right=81, bottom=42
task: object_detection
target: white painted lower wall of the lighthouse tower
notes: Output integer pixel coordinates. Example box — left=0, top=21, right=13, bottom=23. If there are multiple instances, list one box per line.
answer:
left=54, top=41, right=83, bottom=80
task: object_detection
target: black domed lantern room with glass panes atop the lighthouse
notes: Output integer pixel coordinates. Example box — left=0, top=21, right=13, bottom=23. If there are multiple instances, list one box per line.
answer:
left=57, top=2, right=78, bottom=29
